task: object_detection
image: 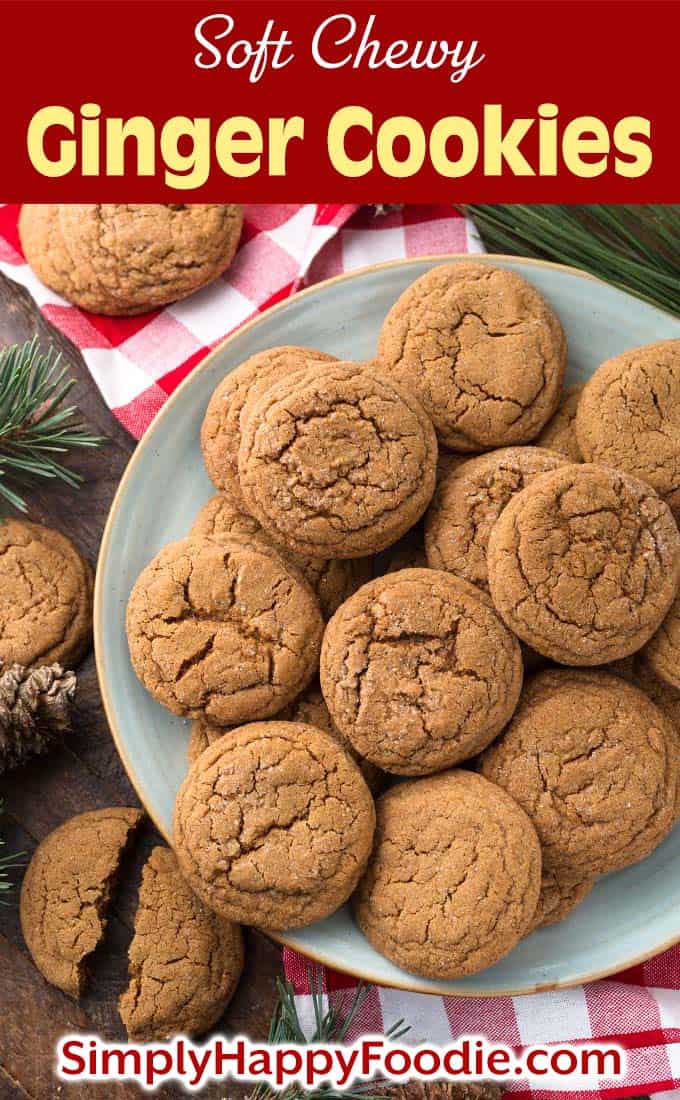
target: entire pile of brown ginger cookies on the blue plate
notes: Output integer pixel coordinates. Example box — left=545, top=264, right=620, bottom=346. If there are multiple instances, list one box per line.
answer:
left=123, top=261, right=680, bottom=979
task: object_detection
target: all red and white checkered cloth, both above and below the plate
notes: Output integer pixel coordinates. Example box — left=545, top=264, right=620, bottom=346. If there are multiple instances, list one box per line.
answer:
left=0, top=205, right=680, bottom=1100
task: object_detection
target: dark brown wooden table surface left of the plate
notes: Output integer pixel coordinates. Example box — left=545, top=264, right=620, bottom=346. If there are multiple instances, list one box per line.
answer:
left=0, top=268, right=281, bottom=1100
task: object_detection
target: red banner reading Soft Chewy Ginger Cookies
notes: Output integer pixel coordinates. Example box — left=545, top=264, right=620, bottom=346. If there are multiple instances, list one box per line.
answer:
left=2, top=0, right=679, bottom=202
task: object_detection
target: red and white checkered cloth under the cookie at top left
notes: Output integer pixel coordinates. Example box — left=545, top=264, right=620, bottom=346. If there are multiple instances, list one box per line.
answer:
left=0, top=204, right=481, bottom=439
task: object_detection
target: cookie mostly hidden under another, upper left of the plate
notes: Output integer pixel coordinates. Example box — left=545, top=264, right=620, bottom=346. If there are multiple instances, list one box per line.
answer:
left=200, top=347, right=336, bottom=504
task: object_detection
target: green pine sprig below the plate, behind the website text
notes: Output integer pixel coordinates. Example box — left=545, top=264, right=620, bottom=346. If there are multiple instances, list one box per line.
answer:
left=250, top=968, right=409, bottom=1100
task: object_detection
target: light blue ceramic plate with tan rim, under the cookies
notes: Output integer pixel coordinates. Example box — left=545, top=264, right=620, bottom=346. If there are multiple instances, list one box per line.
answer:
left=95, top=256, right=680, bottom=996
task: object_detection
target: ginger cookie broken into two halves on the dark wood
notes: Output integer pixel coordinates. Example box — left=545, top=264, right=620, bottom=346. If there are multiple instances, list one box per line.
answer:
left=21, top=806, right=243, bottom=1042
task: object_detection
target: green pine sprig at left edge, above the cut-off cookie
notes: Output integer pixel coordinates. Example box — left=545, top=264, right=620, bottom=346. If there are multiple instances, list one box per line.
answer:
left=0, top=338, right=105, bottom=512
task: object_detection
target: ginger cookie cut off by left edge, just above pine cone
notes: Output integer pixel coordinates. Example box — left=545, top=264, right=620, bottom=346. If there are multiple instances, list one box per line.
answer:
left=0, top=519, right=92, bottom=668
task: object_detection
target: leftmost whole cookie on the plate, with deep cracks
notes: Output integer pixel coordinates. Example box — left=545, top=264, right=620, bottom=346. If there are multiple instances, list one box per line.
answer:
left=128, top=535, right=323, bottom=725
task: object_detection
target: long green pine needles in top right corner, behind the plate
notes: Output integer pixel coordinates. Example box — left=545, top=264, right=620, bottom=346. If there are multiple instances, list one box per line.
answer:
left=463, top=205, right=680, bottom=314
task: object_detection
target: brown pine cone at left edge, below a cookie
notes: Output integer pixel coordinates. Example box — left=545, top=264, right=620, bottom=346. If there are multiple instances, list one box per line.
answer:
left=0, top=663, right=77, bottom=774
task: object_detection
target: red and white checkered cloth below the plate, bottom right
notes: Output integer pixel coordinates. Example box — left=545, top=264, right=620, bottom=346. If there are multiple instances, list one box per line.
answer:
left=284, top=947, right=680, bottom=1100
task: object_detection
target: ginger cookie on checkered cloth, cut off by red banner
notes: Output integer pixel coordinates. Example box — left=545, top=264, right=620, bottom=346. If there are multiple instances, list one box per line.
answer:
left=19, top=202, right=243, bottom=317
